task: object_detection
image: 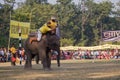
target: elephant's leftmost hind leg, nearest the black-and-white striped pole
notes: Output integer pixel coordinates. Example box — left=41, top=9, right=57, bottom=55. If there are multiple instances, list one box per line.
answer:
left=24, top=52, right=32, bottom=69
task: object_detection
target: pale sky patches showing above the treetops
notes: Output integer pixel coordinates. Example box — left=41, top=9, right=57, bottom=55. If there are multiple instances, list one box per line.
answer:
left=0, top=0, right=120, bottom=8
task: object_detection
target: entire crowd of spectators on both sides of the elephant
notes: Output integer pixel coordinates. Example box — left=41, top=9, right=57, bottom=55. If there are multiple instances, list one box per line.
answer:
left=0, top=45, right=120, bottom=66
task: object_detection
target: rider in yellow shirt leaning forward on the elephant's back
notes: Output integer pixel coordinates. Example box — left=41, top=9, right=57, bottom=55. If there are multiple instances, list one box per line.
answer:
left=30, top=17, right=57, bottom=43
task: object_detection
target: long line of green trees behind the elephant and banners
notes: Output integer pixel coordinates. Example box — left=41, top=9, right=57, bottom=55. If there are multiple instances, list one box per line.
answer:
left=0, top=0, right=120, bottom=47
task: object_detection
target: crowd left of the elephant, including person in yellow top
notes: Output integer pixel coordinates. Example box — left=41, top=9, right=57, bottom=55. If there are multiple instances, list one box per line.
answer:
left=0, top=45, right=25, bottom=66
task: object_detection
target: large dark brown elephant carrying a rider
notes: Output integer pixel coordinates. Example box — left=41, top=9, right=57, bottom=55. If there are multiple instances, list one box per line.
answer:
left=24, top=32, right=60, bottom=69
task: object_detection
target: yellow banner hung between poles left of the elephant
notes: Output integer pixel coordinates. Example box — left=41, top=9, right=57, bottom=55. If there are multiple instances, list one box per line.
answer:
left=10, top=20, right=30, bottom=39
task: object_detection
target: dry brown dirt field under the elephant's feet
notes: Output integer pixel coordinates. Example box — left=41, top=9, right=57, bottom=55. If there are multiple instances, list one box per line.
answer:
left=0, top=59, right=120, bottom=80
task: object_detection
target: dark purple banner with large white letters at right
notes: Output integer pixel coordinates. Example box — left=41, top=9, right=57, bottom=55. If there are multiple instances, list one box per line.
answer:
left=102, top=30, right=120, bottom=41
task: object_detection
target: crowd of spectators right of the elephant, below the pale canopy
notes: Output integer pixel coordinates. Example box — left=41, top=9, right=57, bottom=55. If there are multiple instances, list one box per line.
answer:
left=61, top=48, right=120, bottom=59
